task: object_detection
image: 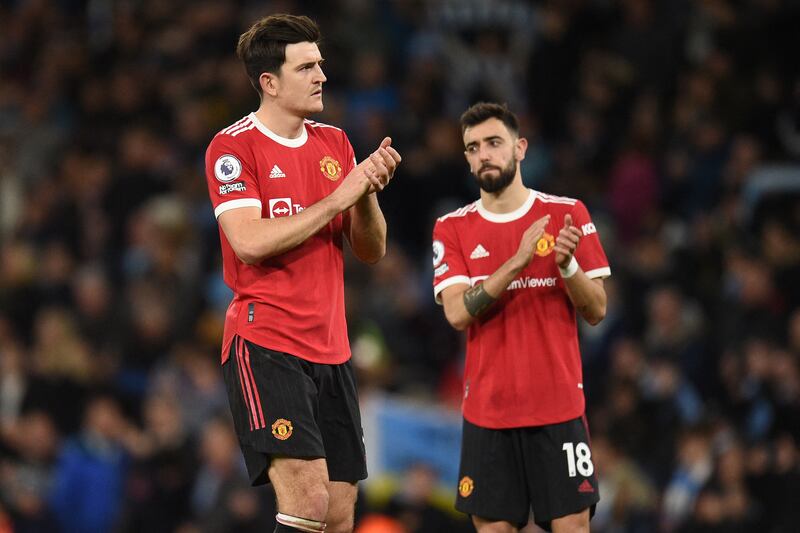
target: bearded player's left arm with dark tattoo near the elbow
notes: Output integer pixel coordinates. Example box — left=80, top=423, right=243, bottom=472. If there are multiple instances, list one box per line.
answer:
left=442, top=215, right=550, bottom=331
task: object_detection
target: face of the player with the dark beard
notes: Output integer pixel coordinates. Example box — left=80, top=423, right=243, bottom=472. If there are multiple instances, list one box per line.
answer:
left=464, top=118, right=526, bottom=192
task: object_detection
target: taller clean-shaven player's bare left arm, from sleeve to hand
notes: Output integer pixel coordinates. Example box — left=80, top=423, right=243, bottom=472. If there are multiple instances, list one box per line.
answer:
left=218, top=153, right=385, bottom=265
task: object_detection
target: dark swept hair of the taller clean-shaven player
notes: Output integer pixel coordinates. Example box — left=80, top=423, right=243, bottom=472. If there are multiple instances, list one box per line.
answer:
left=236, top=14, right=320, bottom=96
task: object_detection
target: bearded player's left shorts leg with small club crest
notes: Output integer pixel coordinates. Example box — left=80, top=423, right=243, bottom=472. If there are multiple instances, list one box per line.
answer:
left=456, top=420, right=530, bottom=527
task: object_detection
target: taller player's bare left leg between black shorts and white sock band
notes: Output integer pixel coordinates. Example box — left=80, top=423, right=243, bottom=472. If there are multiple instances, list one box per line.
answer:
left=269, top=457, right=329, bottom=521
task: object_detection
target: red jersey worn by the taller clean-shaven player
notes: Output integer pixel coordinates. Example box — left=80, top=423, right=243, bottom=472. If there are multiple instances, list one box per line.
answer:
left=206, top=113, right=355, bottom=364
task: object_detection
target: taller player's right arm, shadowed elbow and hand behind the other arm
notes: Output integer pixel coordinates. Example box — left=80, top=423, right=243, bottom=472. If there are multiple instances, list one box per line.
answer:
left=346, top=137, right=401, bottom=263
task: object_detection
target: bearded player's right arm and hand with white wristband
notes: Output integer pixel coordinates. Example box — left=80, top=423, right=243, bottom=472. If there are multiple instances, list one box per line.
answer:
left=554, top=215, right=606, bottom=326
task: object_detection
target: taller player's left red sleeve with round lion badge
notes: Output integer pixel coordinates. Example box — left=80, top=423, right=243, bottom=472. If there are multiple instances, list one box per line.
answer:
left=206, top=134, right=261, bottom=218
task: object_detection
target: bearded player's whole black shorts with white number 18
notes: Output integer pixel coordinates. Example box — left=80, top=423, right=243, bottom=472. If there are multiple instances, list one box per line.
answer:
left=456, top=417, right=600, bottom=531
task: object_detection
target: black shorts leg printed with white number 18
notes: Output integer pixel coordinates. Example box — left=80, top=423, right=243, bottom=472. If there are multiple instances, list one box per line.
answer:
left=524, top=418, right=599, bottom=529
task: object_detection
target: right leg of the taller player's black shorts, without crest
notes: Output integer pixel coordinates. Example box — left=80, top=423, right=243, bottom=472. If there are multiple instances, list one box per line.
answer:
left=313, top=361, right=367, bottom=483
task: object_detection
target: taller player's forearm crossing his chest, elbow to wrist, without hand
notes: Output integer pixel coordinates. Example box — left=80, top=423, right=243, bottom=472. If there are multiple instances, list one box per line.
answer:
left=231, top=196, right=341, bottom=265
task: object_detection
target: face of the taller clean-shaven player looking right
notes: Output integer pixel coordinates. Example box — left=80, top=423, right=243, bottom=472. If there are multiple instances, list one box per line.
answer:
left=276, top=42, right=328, bottom=117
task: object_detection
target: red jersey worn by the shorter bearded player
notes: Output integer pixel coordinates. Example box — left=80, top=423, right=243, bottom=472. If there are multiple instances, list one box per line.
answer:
left=433, top=191, right=611, bottom=428
